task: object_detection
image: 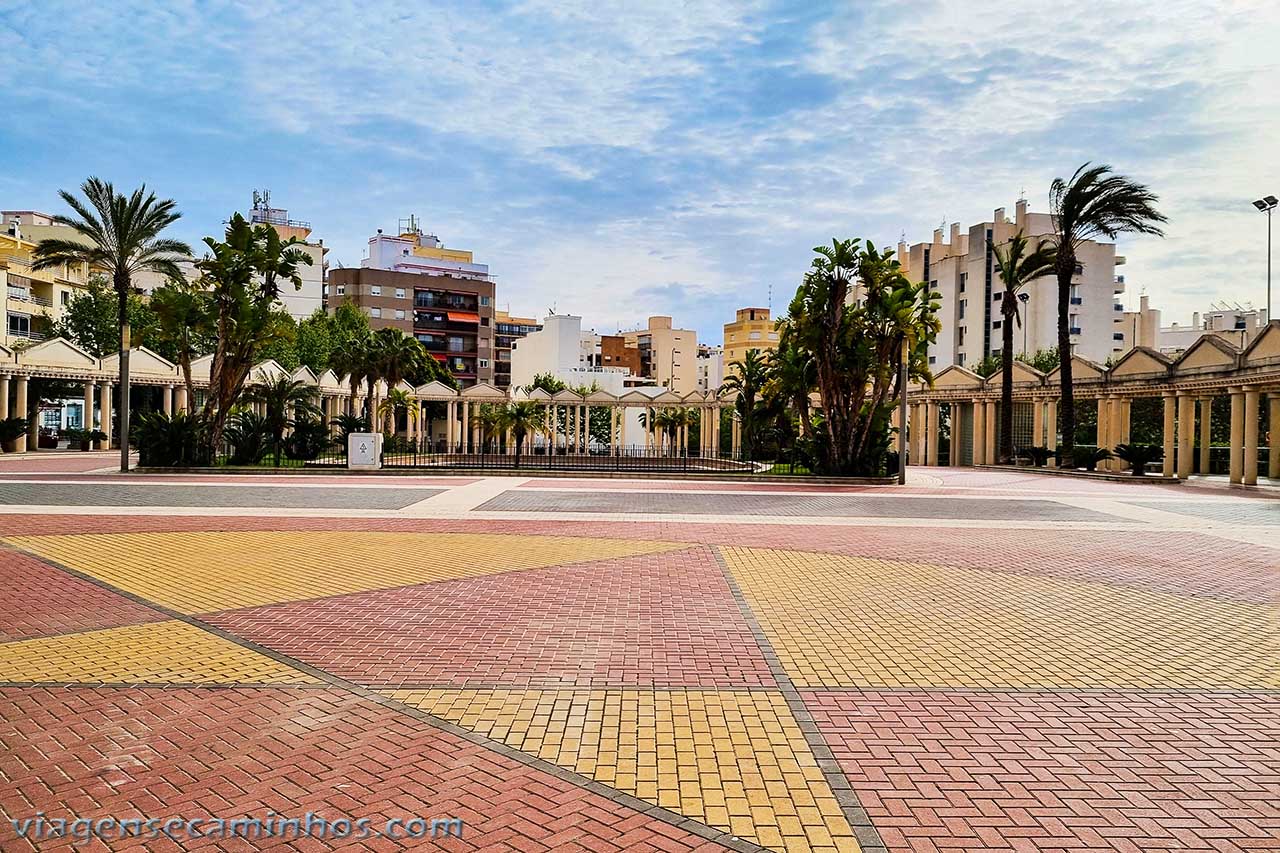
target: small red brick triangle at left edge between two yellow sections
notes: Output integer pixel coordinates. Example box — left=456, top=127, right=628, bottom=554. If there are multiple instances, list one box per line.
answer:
left=0, top=549, right=165, bottom=640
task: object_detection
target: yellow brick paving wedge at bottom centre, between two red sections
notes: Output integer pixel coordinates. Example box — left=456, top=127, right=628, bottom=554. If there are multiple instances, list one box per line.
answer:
left=389, top=689, right=859, bottom=852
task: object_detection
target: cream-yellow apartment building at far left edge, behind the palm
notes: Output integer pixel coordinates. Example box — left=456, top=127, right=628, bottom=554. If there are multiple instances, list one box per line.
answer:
left=0, top=210, right=90, bottom=347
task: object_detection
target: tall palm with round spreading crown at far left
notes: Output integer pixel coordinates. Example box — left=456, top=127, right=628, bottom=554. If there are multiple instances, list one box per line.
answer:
left=32, top=177, right=191, bottom=471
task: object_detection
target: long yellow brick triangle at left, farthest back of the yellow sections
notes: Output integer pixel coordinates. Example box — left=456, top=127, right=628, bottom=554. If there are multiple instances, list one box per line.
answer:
left=8, top=532, right=689, bottom=613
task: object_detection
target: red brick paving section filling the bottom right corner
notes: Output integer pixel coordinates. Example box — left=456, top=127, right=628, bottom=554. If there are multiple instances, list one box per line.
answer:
left=803, top=690, right=1280, bottom=853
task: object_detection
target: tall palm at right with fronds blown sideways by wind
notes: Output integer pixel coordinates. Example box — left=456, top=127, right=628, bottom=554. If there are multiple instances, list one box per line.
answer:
left=1048, top=163, right=1167, bottom=467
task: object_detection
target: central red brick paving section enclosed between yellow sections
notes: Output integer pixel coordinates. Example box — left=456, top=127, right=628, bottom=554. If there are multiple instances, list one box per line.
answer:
left=201, top=548, right=774, bottom=686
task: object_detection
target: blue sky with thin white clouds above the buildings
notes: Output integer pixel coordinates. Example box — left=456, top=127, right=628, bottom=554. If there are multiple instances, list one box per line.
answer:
left=0, top=0, right=1280, bottom=342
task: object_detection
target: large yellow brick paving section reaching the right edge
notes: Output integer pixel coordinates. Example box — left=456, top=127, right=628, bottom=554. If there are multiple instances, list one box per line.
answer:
left=721, top=547, right=1280, bottom=689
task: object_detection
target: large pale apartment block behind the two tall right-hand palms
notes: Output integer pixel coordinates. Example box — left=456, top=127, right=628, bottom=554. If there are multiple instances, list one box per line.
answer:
left=896, top=201, right=1125, bottom=371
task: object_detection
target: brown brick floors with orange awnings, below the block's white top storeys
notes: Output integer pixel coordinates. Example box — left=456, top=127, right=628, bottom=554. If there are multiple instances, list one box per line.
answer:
left=329, top=266, right=495, bottom=386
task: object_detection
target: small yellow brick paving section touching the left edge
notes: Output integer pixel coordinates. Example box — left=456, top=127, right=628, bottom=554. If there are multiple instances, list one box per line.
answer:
left=0, top=621, right=315, bottom=684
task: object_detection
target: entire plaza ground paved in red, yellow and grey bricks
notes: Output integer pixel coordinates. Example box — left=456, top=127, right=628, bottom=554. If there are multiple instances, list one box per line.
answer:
left=0, top=453, right=1280, bottom=853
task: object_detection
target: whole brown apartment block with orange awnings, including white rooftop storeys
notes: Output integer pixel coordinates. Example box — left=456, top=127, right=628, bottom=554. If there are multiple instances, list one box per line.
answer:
left=326, top=222, right=495, bottom=386
